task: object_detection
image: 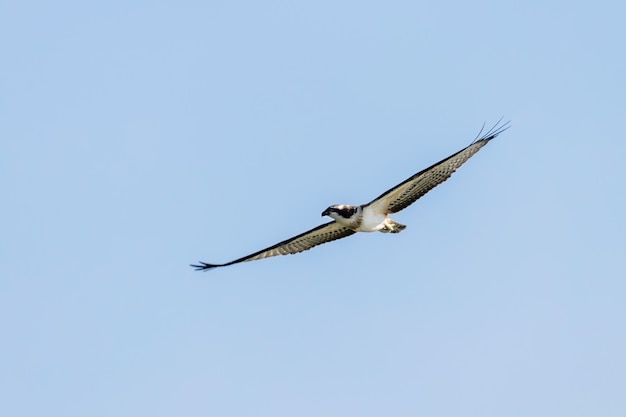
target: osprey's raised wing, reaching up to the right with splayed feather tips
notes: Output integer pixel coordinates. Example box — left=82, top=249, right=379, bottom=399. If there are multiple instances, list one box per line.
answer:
left=366, top=121, right=509, bottom=214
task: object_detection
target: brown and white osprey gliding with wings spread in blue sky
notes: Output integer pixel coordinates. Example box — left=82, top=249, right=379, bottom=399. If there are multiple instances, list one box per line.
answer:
left=191, top=121, right=510, bottom=270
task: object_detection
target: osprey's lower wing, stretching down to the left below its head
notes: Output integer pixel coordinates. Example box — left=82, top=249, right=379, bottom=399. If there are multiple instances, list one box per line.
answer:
left=191, top=220, right=356, bottom=271
